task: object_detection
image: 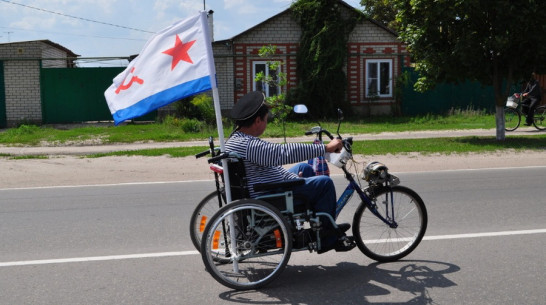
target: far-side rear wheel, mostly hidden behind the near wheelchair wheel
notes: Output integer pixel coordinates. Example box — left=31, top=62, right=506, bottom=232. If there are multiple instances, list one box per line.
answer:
left=190, top=191, right=225, bottom=251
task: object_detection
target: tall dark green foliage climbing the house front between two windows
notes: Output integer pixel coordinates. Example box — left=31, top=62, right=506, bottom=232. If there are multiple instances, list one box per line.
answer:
left=290, top=0, right=354, bottom=115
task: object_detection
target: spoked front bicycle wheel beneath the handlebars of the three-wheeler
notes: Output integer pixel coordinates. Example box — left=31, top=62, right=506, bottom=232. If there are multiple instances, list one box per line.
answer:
left=353, top=186, right=428, bottom=262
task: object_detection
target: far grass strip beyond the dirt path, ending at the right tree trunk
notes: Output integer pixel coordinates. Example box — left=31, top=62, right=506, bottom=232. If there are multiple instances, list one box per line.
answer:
left=0, top=114, right=495, bottom=146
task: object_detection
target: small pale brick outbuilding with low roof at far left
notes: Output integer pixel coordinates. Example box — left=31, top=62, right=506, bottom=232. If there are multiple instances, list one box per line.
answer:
left=0, top=40, right=79, bottom=127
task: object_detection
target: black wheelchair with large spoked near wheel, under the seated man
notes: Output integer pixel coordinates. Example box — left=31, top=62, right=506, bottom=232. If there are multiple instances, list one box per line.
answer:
left=200, top=154, right=344, bottom=290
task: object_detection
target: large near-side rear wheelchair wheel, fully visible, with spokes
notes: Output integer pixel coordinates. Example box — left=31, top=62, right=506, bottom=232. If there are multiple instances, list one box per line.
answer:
left=201, top=199, right=292, bottom=290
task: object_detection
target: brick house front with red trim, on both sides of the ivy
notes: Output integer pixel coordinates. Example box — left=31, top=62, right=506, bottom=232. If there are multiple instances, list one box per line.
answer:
left=213, top=1, right=409, bottom=114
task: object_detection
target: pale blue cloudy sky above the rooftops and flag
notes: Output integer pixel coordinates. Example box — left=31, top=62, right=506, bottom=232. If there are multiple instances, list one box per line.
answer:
left=0, top=0, right=366, bottom=67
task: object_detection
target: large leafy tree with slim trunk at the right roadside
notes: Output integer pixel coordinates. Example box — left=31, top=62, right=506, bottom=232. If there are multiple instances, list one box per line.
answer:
left=392, top=0, right=546, bottom=140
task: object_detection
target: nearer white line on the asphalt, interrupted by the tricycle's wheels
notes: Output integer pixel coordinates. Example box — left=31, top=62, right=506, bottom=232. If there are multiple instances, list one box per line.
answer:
left=0, top=229, right=546, bottom=267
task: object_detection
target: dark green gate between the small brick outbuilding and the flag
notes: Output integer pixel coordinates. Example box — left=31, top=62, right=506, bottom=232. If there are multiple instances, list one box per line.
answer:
left=40, top=68, right=157, bottom=124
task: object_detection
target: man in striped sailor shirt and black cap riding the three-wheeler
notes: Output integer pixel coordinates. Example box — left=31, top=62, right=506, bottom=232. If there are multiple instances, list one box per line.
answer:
left=225, top=91, right=355, bottom=253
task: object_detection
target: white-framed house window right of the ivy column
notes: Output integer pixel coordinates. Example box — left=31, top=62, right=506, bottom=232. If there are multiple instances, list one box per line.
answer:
left=365, top=59, right=392, bottom=97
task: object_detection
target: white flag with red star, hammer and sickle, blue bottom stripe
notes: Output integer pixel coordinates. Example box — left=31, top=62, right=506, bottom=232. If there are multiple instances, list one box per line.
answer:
left=104, top=12, right=216, bottom=125
